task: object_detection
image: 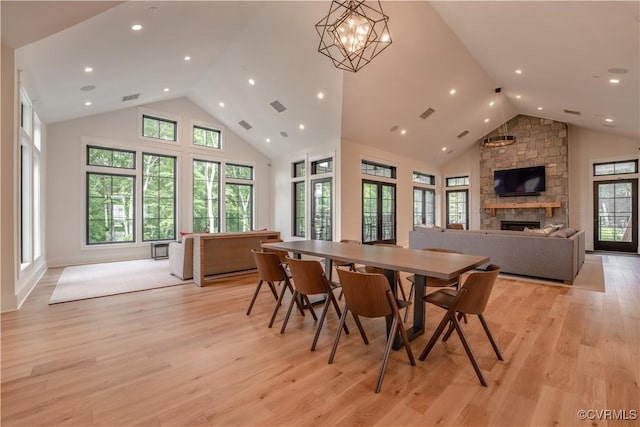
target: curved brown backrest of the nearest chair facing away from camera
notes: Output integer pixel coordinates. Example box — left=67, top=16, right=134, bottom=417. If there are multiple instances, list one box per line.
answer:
left=338, top=270, right=393, bottom=317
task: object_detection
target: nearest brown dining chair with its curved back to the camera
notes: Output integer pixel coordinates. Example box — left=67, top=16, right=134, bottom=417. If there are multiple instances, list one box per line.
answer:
left=329, top=269, right=416, bottom=393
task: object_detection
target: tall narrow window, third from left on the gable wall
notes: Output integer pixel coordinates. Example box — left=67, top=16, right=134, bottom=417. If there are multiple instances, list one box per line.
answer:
left=193, top=160, right=220, bottom=233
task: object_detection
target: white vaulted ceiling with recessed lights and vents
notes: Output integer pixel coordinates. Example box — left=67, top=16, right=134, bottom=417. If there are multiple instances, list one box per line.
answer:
left=2, top=1, right=640, bottom=164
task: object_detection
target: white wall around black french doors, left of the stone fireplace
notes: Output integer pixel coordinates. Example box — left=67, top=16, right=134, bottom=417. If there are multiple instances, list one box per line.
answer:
left=342, top=140, right=442, bottom=246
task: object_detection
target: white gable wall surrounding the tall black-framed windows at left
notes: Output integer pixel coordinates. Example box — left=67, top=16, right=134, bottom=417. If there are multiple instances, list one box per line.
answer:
left=46, top=98, right=272, bottom=266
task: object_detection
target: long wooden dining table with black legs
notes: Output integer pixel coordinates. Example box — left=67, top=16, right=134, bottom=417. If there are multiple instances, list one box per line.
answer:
left=262, top=240, right=489, bottom=350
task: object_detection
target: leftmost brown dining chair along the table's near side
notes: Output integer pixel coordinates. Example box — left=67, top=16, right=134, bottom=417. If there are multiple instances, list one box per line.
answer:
left=247, top=249, right=304, bottom=327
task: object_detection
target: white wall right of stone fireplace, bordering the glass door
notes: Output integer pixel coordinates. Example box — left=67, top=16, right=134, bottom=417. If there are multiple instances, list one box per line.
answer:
left=569, top=126, right=640, bottom=250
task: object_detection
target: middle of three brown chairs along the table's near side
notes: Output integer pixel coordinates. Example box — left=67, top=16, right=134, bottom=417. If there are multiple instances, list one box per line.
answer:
left=280, top=258, right=349, bottom=351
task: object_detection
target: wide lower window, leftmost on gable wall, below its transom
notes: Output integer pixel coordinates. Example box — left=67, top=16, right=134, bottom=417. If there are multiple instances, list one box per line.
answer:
left=87, top=172, right=135, bottom=245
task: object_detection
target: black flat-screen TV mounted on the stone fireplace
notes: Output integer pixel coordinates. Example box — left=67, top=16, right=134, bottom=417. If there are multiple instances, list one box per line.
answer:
left=493, top=166, right=546, bottom=196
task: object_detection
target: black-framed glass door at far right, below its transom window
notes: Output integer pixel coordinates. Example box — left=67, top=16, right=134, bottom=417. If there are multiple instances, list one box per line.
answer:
left=593, top=179, right=638, bottom=253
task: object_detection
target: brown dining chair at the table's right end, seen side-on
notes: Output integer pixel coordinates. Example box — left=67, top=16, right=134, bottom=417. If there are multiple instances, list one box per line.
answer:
left=420, top=264, right=504, bottom=387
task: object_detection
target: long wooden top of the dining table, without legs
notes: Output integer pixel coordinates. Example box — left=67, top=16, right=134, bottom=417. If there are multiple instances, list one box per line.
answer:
left=262, top=240, right=489, bottom=280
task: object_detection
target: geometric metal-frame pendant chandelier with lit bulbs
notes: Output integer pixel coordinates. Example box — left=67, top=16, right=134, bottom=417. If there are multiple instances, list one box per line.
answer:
left=316, top=0, right=391, bottom=73
